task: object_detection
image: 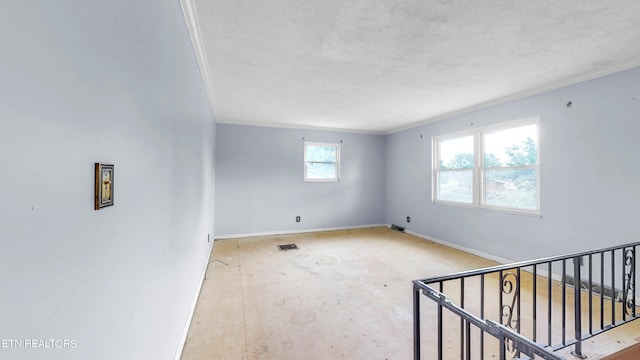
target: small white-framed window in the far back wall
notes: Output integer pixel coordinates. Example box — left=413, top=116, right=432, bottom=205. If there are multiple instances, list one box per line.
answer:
left=304, top=142, right=340, bottom=182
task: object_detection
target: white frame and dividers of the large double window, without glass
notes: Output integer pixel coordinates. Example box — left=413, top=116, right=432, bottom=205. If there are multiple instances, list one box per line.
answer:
left=431, top=116, right=541, bottom=216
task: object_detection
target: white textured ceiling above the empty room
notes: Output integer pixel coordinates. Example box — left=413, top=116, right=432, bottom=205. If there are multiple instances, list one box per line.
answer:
left=183, top=0, right=640, bottom=133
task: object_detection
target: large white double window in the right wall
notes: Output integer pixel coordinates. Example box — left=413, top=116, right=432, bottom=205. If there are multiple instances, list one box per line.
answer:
left=433, top=117, right=540, bottom=214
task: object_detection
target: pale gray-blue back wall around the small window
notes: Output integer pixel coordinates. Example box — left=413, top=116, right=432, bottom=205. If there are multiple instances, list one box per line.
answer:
left=216, top=124, right=385, bottom=237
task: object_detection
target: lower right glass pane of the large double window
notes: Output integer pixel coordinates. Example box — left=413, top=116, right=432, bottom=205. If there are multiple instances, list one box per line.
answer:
left=484, top=169, right=538, bottom=210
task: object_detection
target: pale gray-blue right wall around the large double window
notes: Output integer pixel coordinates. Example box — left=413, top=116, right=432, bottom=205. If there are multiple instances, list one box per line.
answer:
left=385, top=68, right=640, bottom=260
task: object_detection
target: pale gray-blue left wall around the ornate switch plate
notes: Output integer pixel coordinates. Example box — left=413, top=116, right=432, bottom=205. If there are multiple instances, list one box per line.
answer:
left=0, top=0, right=215, bottom=360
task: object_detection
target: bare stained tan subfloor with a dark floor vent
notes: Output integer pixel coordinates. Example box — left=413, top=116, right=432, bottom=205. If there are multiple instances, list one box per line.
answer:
left=182, top=228, right=640, bottom=360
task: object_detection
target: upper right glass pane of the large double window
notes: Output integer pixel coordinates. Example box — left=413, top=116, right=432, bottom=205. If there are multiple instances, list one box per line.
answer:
left=484, top=124, right=538, bottom=167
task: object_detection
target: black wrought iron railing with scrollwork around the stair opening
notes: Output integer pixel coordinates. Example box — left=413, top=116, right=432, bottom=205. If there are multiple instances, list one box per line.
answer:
left=413, top=242, right=640, bottom=360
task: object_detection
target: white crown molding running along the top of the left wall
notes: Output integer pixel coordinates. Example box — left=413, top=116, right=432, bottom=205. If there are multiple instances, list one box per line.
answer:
left=180, top=0, right=218, bottom=120
